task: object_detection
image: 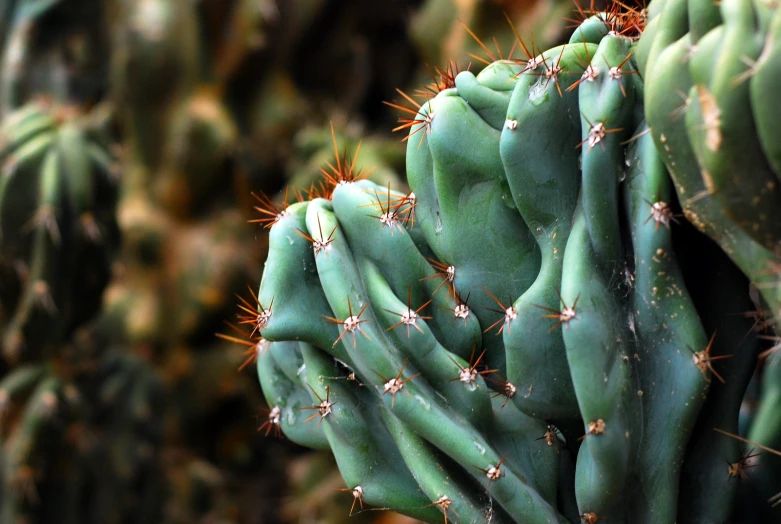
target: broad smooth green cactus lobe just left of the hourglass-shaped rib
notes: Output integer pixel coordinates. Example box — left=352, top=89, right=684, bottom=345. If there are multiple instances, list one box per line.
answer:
left=407, top=90, right=540, bottom=375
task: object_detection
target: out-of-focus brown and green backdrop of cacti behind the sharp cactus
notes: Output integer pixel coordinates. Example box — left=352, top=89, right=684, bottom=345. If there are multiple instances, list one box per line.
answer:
left=0, top=0, right=574, bottom=524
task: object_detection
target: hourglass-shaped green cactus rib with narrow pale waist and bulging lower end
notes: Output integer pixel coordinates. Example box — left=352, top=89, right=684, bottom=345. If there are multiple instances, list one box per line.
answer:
left=500, top=44, right=596, bottom=420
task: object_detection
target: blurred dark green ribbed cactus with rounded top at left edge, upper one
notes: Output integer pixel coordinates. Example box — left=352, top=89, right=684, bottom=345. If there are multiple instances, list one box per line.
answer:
left=0, top=100, right=118, bottom=360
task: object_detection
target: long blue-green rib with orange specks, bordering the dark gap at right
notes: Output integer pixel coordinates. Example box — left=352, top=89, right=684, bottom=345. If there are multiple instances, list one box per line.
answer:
left=625, top=125, right=712, bottom=522
